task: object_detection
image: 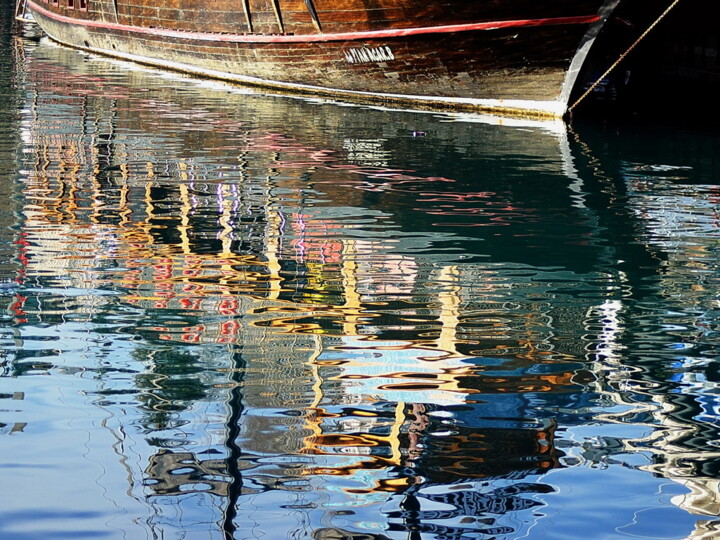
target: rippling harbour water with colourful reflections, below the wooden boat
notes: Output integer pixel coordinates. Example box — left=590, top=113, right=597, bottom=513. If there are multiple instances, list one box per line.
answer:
left=0, top=5, right=720, bottom=540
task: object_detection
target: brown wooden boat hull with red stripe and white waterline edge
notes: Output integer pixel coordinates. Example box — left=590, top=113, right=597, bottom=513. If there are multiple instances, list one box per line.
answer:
left=22, top=0, right=617, bottom=117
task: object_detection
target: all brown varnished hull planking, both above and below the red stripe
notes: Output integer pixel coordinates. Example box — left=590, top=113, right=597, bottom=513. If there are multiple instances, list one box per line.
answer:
left=25, top=0, right=616, bottom=114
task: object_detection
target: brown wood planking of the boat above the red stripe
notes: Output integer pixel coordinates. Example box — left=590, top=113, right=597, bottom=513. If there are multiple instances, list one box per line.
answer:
left=35, top=0, right=601, bottom=34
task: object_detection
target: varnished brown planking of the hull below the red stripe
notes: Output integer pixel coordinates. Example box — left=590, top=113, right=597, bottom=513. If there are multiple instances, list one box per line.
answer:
left=35, top=5, right=580, bottom=99
